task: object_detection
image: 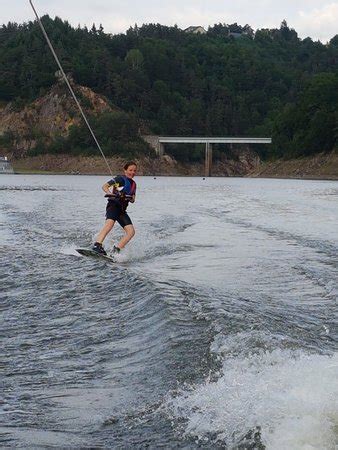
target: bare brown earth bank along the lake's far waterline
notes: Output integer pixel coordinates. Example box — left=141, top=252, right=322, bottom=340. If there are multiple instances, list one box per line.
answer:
left=3, top=152, right=338, bottom=181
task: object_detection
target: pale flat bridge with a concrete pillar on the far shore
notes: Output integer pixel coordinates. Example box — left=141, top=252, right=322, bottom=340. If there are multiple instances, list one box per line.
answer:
left=142, top=135, right=272, bottom=177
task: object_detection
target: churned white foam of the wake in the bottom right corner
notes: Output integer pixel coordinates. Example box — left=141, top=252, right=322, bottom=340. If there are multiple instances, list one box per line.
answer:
left=166, top=332, right=338, bottom=450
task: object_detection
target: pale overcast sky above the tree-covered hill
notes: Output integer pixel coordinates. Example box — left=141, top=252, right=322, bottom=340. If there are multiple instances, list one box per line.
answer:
left=0, top=0, right=338, bottom=43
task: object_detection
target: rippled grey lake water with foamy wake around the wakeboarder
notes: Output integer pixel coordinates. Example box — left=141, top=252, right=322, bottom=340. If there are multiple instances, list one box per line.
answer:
left=0, top=175, right=338, bottom=449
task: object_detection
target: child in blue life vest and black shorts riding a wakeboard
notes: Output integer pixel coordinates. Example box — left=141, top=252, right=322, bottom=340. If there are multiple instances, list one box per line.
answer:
left=93, top=161, right=137, bottom=255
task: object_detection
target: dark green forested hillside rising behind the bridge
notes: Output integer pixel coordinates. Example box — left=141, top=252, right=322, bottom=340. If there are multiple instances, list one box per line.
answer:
left=0, top=16, right=338, bottom=158
